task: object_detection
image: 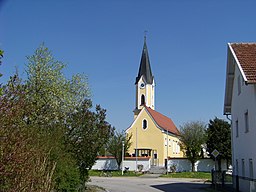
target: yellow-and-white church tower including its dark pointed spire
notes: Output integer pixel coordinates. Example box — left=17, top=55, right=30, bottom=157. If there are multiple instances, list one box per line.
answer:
left=133, top=36, right=155, bottom=119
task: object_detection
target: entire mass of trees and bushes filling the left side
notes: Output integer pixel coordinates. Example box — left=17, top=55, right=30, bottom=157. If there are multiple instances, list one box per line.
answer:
left=0, top=45, right=112, bottom=192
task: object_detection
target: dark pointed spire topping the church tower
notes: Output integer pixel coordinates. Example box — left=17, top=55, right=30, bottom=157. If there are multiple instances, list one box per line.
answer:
left=135, top=35, right=153, bottom=84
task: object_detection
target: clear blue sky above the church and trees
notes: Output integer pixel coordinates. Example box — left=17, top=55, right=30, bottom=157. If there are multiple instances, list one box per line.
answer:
left=0, top=0, right=256, bottom=130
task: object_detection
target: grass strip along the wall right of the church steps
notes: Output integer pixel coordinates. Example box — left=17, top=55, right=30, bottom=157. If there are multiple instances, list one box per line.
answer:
left=161, top=172, right=211, bottom=180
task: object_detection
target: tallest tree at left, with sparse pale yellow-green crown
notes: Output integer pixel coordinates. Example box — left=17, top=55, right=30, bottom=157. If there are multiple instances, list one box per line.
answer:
left=25, top=45, right=89, bottom=191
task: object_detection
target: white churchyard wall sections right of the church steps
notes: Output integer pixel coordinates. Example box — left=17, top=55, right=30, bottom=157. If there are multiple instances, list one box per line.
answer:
left=168, top=158, right=227, bottom=172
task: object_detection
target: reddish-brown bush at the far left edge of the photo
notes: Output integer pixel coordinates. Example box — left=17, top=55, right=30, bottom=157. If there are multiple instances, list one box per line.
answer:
left=0, top=75, right=52, bottom=191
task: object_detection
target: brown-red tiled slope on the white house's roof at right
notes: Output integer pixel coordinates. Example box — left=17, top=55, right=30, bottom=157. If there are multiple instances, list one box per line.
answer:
left=231, top=43, right=256, bottom=83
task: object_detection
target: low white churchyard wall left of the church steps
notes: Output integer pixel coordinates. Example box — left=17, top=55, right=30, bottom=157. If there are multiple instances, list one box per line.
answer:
left=92, top=157, right=151, bottom=171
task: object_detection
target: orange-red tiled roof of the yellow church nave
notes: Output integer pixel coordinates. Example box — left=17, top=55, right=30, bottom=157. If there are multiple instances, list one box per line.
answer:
left=145, top=106, right=179, bottom=135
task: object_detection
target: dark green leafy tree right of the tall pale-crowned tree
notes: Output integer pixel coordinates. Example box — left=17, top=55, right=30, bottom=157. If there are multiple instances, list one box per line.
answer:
left=67, top=100, right=113, bottom=188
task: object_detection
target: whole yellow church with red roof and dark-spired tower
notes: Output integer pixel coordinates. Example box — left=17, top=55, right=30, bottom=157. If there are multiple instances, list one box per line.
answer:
left=126, top=37, right=183, bottom=166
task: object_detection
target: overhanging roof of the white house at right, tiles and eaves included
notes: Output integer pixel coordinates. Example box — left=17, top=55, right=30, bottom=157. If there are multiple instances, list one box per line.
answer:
left=224, top=43, right=256, bottom=115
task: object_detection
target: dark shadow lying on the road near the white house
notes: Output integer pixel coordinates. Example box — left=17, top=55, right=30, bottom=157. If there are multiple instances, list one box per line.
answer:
left=151, top=183, right=211, bottom=192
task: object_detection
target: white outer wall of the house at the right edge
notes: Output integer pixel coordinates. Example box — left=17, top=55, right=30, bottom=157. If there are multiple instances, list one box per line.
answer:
left=231, top=59, right=256, bottom=191
